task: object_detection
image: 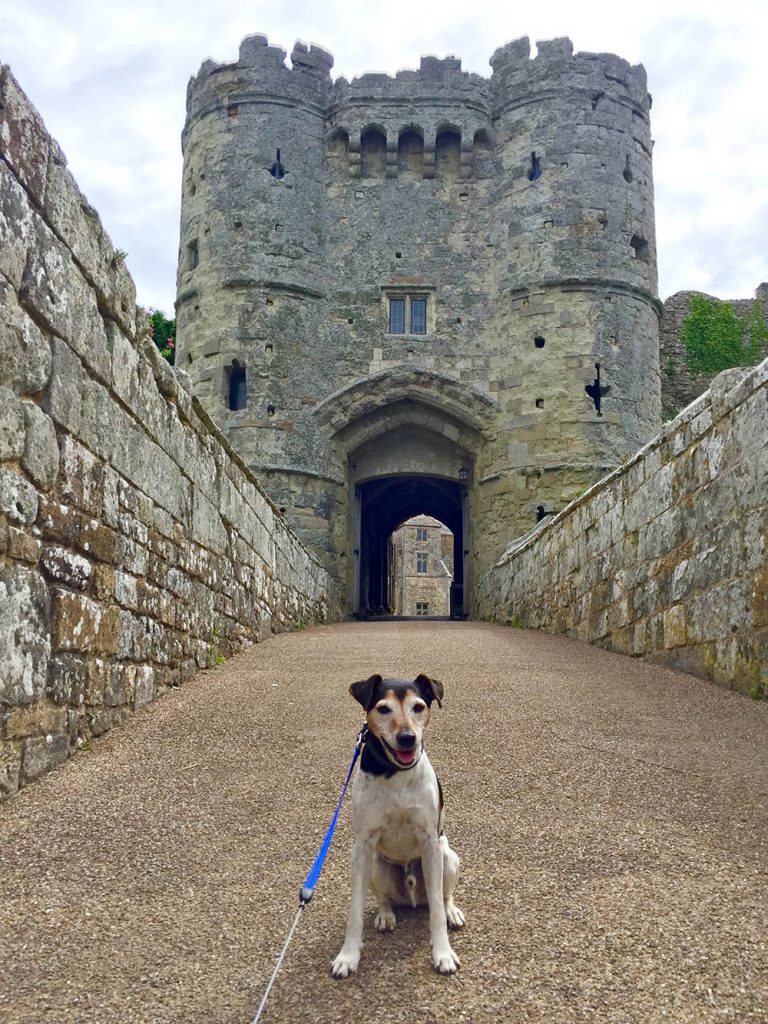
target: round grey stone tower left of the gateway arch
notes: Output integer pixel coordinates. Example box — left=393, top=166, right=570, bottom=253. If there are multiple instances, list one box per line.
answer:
left=176, top=36, right=333, bottom=546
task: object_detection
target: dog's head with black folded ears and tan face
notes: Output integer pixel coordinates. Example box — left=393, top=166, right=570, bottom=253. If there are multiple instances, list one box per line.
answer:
left=349, top=675, right=442, bottom=768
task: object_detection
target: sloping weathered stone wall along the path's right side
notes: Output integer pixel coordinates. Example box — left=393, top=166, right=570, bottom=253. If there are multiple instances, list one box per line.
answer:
left=480, top=360, right=768, bottom=696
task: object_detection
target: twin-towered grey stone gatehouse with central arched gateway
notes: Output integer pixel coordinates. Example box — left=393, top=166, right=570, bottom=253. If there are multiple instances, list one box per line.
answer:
left=177, top=36, right=660, bottom=613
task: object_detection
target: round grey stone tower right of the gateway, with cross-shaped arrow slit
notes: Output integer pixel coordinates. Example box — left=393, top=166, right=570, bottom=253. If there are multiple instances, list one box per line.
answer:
left=490, top=39, right=660, bottom=475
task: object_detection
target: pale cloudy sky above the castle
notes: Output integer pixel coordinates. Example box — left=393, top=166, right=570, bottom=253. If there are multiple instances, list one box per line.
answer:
left=0, top=0, right=768, bottom=314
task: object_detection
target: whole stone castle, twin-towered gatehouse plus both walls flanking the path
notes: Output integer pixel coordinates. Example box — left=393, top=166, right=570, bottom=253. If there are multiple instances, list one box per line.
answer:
left=0, top=37, right=768, bottom=799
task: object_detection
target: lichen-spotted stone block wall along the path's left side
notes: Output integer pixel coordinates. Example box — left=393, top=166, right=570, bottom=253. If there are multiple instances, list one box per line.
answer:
left=0, top=68, right=335, bottom=796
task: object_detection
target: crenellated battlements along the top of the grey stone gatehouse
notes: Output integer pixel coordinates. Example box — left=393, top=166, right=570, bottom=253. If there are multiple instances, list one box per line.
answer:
left=187, top=35, right=650, bottom=144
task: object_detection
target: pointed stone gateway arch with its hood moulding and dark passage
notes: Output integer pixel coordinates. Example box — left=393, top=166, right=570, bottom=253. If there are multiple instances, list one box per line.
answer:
left=314, top=367, right=496, bottom=615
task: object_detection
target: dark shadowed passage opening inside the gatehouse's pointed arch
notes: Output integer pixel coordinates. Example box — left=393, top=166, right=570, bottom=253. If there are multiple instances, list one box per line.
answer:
left=355, top=475, right=469, bottom=617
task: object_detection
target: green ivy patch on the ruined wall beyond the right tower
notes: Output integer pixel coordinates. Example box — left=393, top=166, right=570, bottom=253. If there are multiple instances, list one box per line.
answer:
left=681, top=295, right=768, bottom=377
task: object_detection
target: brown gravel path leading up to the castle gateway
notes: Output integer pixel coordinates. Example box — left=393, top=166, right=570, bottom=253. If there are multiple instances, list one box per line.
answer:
left=0, top=622, right=768, bottom=1024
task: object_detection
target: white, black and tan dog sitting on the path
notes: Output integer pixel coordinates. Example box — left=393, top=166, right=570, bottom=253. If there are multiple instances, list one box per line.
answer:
left=331, top=675, right=464, bottom=978
